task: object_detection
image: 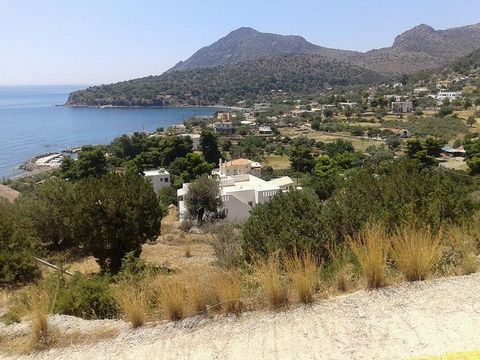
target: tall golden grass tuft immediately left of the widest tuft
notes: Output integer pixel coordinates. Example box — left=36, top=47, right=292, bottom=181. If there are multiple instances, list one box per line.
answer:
left=347, top=224, right=388, bottom=289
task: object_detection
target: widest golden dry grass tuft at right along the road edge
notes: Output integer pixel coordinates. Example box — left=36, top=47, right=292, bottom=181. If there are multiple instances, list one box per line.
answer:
left=391, top=227, right=440, bottom=281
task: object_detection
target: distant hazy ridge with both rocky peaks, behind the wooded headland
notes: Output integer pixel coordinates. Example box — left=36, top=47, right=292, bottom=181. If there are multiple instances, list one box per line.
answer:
left=168, top=24, right=480, bottom=74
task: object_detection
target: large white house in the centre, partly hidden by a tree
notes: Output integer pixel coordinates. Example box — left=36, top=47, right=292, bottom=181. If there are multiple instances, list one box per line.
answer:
left=177, top=159, right=294, bottom=222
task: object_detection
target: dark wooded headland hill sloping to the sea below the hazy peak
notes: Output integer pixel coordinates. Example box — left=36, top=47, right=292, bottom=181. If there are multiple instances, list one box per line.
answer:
left=67, top=54, right=383, bottom=106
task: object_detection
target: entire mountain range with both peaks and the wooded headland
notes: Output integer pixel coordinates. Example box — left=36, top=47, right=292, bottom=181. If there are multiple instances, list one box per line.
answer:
left=67, top=24, right=480, bottom=106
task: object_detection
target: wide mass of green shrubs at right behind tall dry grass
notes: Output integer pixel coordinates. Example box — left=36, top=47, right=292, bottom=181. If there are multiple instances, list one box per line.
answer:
left=317, top=160, right=473, bottom=243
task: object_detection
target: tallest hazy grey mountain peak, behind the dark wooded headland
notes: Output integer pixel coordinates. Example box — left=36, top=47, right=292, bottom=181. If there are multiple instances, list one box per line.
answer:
left=169, top=27, right=356, bottom=71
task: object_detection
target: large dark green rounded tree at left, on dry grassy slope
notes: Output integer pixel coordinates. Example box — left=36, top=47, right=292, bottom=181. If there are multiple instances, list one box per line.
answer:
left=72, top=173, right=162, bottom=273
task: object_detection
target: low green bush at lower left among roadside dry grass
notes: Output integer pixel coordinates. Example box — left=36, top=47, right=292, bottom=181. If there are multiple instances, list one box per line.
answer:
left=54, top=275, right=117, bottom=319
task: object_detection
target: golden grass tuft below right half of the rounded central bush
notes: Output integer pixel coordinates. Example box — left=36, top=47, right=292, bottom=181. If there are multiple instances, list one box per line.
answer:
left=285, top=252, right=319, bottom=304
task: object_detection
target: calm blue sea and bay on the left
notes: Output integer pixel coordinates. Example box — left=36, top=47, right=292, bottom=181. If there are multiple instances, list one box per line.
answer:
left=0, top=86, right=216, bottom=178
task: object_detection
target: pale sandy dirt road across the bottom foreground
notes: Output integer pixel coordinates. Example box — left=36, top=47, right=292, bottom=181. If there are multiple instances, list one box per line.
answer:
left=0, top=274, right=480, bottom=360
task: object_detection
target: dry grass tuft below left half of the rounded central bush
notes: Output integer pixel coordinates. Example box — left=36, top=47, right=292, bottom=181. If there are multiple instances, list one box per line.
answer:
left=254, top=255, right=288, bottom=308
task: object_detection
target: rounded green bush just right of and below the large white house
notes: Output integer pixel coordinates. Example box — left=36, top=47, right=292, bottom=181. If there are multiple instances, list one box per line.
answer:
left=242, top=191, right=322, bottom=262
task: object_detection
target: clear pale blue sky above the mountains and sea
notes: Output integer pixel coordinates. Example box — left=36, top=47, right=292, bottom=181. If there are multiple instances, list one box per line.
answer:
left=0, top=0, right=480, bottom=85
